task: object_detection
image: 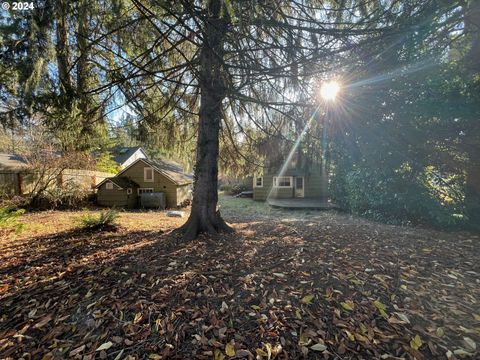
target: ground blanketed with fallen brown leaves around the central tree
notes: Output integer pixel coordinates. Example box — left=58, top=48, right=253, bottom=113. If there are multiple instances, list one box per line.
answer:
left=0, top=198, right=480, bottom=359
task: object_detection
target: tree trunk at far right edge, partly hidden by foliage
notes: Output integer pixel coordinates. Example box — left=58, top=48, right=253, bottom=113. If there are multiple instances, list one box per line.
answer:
left=464, top=0, right=480, bottom=229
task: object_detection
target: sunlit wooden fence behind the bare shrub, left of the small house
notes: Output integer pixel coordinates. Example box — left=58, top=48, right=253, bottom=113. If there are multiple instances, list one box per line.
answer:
left=0, top=169, right=115, bottom=197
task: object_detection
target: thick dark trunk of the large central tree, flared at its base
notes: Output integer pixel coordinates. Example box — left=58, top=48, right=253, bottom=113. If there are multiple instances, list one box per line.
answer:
left=180, top=0, right=232, bottom=240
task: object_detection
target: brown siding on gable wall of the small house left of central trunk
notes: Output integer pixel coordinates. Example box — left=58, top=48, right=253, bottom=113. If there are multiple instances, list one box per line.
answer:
left=121, top=161, right=179, bottom=208
